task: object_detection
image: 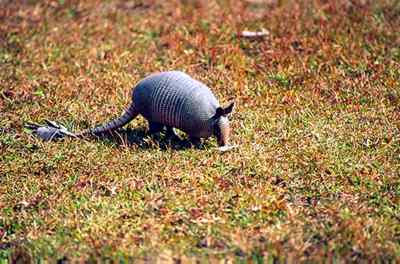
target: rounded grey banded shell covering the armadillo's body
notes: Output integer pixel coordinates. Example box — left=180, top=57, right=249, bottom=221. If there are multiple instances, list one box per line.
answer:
left=133, top=71, right=219, bottom=137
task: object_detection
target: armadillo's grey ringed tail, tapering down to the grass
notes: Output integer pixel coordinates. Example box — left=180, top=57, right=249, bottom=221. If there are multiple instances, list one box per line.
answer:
left=76, top=103, right=139, bottom=137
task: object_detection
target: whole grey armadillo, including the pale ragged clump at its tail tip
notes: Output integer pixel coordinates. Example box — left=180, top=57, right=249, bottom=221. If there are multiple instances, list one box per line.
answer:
left=28, top=71, right=234, bottom=148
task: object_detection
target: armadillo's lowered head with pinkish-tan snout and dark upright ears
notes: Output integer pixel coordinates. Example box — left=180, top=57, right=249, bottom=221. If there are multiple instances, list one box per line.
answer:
left=213, top=102, right=234, bottom=146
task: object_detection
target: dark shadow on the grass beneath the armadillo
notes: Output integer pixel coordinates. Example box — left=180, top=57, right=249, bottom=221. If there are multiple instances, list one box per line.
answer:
left=97, top=128, right=207, bottom=150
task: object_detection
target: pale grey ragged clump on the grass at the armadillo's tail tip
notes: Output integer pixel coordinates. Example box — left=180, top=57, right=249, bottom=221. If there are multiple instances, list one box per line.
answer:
left=25, top=120, right=76, bottom=141
